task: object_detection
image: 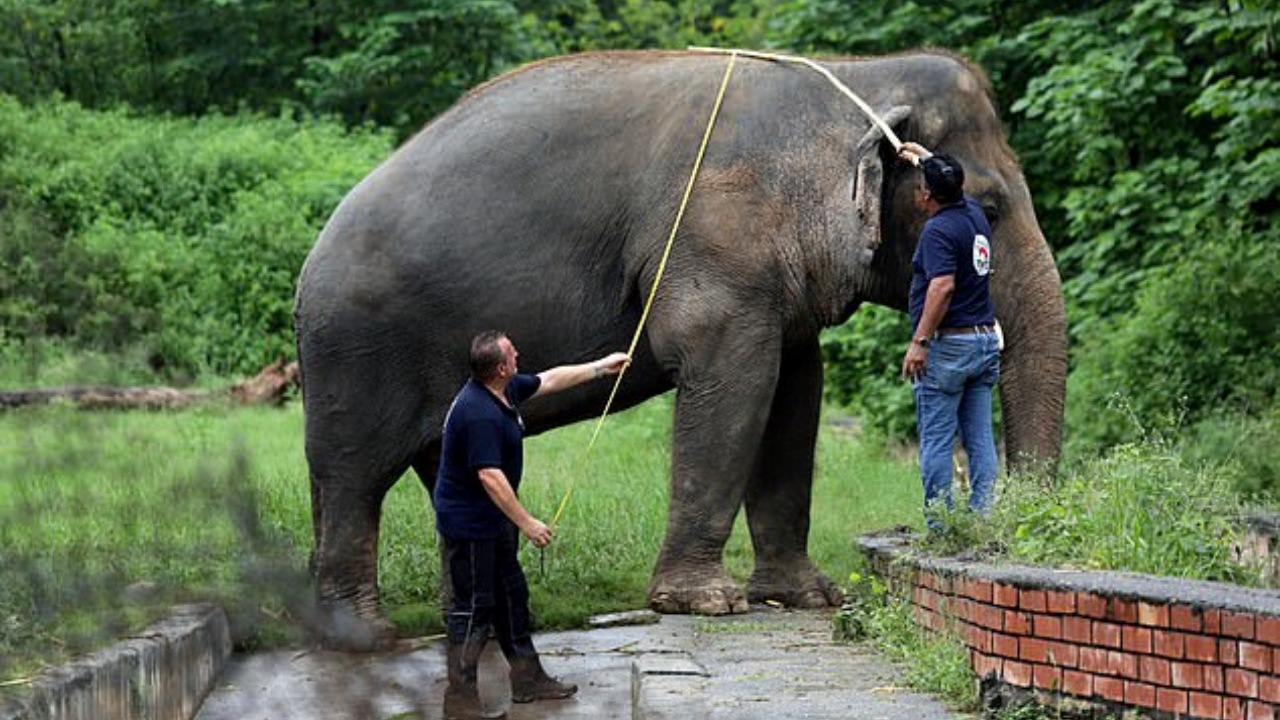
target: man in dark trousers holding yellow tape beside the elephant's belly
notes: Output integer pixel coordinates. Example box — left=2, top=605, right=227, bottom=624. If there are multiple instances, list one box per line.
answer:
left=433, top=332, right=628, bottom=720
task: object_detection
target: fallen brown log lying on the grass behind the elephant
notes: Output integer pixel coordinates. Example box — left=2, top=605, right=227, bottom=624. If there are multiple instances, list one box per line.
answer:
left=0, top=357, right=300, bottom=410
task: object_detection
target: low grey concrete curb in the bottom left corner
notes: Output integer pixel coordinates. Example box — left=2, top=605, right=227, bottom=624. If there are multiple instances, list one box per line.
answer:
left=0, top=605, right=232, bottom=720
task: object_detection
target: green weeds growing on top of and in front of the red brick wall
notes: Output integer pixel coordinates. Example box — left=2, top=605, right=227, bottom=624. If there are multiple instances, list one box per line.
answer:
left=835, top=417, right=1263, bottom=720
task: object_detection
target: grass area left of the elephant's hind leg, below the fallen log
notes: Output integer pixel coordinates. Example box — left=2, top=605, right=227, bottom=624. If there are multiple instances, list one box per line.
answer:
left=0, top=406, right=317, bottom=671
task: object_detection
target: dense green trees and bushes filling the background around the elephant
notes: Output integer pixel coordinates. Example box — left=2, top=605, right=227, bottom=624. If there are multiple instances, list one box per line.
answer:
left=0, top=0, right=1280, bottom=489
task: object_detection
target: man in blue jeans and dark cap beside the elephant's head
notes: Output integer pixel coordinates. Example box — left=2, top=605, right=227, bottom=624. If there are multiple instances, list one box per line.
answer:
left=900, top=142, right=1000, bottom=530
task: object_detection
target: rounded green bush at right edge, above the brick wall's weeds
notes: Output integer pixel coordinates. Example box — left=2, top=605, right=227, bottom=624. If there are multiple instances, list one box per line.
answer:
left=1068, top=238, right=1280, bottom=455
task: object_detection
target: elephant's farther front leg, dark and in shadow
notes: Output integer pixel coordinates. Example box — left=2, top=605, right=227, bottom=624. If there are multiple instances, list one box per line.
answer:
left=746, top=341, right=844, bottom=607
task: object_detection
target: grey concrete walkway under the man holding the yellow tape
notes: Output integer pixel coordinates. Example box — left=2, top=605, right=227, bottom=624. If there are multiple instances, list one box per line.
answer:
left=196, top=609, right=961, bottom=720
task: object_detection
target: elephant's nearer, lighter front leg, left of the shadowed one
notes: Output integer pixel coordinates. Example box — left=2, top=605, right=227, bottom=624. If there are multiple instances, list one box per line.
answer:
left=649, top=325, right=778, bottom=615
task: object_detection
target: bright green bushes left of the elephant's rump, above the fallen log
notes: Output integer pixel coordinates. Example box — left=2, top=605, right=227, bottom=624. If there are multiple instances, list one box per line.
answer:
left=0, top=96, right=390, bottom=375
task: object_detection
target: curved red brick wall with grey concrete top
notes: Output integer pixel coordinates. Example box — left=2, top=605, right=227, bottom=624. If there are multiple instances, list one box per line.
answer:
left=859, top=536, right=1280, bottom=720
